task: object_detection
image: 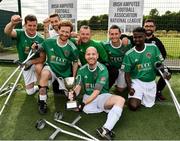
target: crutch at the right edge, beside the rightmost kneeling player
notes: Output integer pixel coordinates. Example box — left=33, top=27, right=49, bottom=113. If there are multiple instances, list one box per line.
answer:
left=155, top=63, right=180, bottom=117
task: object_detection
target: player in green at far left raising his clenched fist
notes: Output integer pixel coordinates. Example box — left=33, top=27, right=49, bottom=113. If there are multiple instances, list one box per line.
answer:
left=4, top=15, right=45, bottom=95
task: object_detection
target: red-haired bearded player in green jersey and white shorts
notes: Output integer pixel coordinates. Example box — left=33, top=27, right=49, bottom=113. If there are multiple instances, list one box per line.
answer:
left=36, top=21, right=78, bottom=114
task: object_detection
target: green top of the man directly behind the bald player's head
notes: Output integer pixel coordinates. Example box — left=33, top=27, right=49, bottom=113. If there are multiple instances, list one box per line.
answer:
left=77, top=40, right=108, bottom=65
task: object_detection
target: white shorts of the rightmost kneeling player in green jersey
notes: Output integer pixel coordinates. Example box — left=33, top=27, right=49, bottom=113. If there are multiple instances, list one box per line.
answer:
left=128, top=79, right=156, bottom=107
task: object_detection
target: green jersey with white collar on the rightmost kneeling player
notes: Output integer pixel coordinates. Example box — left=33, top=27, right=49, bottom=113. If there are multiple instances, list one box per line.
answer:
left=121, top=44, right=163, bottom=82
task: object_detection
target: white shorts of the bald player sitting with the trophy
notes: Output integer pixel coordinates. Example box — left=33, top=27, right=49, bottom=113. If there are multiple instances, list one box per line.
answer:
left=83, top=93, right=112, bottom=114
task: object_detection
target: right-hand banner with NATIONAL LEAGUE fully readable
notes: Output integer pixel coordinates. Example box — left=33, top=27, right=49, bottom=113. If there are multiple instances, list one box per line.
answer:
left=108, top=0, right=144, bottom=33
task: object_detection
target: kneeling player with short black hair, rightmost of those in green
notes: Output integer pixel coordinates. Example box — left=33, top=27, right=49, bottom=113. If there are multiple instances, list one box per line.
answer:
left=121, top=27, right=163, bottom=111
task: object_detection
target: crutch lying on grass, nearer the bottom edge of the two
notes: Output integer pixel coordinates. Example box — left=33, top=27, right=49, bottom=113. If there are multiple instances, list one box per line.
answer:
left=36, top=119, right=93, bottom=141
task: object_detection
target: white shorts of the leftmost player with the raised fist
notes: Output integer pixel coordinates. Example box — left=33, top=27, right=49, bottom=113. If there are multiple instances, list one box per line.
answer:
left=23, top=65, right=37, bottom=86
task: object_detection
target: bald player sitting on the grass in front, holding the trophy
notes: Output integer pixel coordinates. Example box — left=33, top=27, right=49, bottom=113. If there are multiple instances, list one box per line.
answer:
left=69, top=47, right=125, bottom=140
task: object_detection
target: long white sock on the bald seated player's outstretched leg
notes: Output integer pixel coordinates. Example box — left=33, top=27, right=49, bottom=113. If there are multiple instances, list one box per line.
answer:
left=103, top=105, right=123, bottom=131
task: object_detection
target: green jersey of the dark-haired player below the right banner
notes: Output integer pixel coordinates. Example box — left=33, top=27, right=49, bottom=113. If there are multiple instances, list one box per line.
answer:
left=102, top=40, right=132, bottom=69
